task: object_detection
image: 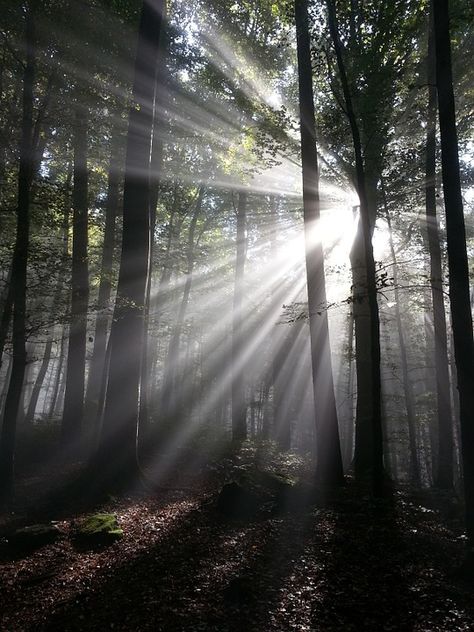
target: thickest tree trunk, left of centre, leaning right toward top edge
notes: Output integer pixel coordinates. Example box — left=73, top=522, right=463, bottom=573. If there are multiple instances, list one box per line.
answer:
left=95, top=0, right=164, bottom=485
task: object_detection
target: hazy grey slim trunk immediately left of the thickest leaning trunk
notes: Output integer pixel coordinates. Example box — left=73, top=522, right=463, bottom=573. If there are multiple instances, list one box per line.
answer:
left=85, top=130, right=121, bottom=431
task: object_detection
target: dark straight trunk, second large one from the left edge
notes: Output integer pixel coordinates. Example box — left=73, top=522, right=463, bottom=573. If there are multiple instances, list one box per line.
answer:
left=61, top=101, right=89, bottom=451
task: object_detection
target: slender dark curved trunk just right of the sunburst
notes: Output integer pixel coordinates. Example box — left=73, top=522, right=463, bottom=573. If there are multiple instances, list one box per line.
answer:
left=327, top=0, right=384, bottom=488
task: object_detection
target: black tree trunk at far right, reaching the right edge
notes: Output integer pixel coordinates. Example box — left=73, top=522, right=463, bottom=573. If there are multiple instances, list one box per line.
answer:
left=432, top=0, right=474, bottom=547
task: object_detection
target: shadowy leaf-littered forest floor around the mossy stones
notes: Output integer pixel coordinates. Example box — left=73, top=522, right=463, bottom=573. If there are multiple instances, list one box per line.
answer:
left=0, top=446, right=474, bottom=632
